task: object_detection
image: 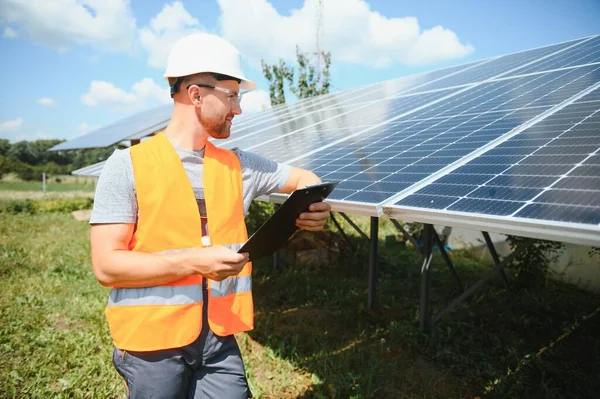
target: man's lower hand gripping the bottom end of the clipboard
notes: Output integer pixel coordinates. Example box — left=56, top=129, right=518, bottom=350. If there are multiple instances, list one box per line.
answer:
left=184, top=245, right=249, bottom=281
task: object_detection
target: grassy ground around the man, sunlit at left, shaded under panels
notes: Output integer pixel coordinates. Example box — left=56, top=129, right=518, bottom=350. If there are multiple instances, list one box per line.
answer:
left=0, top=197, right=600, bottom=398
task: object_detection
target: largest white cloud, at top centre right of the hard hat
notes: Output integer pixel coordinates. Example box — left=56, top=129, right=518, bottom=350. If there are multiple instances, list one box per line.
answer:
left=218, top=0, right=474, bottom=68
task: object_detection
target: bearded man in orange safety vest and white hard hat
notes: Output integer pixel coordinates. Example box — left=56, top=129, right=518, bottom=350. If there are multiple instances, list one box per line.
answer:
left=90, top=34, right=330, bottom=399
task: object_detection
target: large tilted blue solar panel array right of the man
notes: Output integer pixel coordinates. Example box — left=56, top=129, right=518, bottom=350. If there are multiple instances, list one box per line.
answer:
left=65, top=36, right=600, bottom=245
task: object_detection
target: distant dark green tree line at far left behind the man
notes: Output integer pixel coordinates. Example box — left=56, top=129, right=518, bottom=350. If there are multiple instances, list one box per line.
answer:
left=0, top=139, right=118, bottom=180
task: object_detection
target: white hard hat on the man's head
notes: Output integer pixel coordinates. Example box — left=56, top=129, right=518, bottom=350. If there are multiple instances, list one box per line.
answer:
left=164, top=33, right=256, bottom=90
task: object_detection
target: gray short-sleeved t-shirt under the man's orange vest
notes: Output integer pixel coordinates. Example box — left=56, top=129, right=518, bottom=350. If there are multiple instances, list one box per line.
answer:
left=90, top=148, right=291, bottom=229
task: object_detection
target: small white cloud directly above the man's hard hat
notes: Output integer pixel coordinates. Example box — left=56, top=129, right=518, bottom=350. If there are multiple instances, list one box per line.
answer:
left=138, top=1, right=204, bottom=68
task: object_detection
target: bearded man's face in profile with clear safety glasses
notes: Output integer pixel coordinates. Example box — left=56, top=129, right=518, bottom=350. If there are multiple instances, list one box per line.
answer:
left=198, top=80, right=242, bottom=139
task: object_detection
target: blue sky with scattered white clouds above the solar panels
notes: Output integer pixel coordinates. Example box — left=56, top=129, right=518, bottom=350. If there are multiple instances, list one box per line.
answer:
left=0, top=0, right=600, bottom=141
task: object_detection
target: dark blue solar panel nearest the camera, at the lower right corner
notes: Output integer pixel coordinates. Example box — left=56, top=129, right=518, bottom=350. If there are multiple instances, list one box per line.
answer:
left=387, top=84, right=600, bottom=243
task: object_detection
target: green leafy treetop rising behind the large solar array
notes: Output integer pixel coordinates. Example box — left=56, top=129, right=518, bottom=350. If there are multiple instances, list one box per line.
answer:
left=261, top=46, right=331, bottom=106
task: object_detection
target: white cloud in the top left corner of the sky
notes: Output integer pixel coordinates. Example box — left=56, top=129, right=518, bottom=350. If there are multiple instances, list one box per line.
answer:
left=0, top=0, right=135, bottom=51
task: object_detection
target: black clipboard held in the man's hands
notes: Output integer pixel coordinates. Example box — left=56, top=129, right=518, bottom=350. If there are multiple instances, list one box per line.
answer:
left=238, top=182, right=338, bottom=261
